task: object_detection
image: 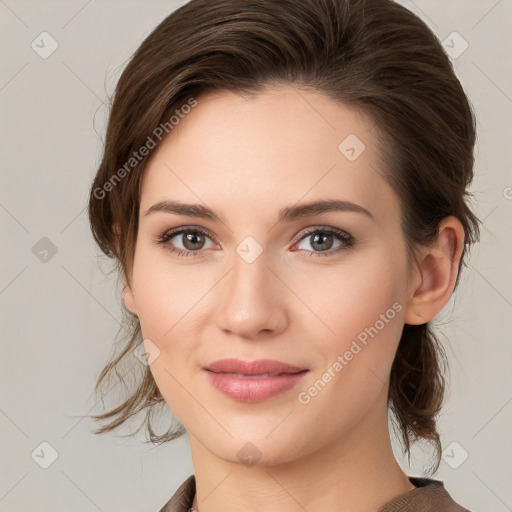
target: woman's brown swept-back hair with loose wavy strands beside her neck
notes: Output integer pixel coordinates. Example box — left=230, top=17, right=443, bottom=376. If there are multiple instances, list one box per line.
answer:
left=89, top=0, right=480, bottom=470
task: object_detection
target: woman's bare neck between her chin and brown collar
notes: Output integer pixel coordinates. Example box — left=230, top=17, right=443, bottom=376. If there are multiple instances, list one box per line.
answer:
left=189, top=398, right=414, bottom=512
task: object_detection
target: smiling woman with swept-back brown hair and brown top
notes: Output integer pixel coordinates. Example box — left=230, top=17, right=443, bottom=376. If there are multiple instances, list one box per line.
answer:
left=89, top=0, right=479, bottom=512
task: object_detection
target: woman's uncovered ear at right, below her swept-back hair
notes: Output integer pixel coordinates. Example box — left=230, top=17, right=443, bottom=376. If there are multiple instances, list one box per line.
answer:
left=404, top=216, right=464, bottom=325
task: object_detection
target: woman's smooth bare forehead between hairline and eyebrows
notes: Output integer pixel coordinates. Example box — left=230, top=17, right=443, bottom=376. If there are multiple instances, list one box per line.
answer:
left=141, top=86, right=396, bottom=226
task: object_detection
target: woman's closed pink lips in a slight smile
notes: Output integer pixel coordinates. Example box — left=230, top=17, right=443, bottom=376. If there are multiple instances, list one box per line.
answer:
left=203, top=359, right=309, bottom=402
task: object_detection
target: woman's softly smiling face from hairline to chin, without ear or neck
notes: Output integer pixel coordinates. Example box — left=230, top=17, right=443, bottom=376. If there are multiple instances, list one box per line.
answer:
left=124, top=86, right=416, bottom=464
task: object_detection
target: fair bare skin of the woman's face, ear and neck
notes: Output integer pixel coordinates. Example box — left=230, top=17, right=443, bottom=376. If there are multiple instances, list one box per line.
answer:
left=123, top=85, right=464, bottom=512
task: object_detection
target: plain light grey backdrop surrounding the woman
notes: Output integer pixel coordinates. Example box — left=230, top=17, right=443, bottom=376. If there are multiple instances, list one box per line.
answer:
left=0, top=0, right=512, bottom=512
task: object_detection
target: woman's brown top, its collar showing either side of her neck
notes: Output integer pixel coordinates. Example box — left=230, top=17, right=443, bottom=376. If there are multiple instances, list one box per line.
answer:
left=159, top=475, right=470, bottom=512
